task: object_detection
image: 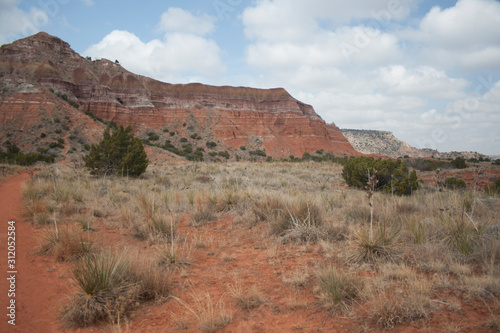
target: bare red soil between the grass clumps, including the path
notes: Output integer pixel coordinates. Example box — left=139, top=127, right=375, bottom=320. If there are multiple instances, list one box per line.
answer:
left=0, top=173, right=498, bottom=332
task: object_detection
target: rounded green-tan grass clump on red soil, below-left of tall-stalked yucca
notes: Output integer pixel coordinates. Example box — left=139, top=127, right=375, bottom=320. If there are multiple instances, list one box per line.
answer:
left=315, top=265, right=363, bottom=310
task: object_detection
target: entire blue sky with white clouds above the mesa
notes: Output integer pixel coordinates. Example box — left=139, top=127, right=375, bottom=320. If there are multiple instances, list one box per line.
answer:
left=0, top=0, right=500, bottom=155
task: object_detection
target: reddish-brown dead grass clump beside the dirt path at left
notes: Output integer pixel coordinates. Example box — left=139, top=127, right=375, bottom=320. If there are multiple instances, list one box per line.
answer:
left=37, top=226, right=92, bottom=261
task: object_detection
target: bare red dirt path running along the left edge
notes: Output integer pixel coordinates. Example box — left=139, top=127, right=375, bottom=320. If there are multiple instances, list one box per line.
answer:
left=0, top=173, right=73, bottom=332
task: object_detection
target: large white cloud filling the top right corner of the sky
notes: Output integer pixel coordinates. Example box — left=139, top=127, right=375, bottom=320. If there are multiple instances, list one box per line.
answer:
left=399, top=0, right=500, bottom=72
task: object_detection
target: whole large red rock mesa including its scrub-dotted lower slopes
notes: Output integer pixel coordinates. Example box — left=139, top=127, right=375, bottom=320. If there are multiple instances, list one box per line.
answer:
left=0, top=32, right=359, bottom=161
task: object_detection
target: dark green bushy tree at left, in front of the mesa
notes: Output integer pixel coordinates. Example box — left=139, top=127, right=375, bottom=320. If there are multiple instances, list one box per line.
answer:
left=83, top=126, right=149, bottom=176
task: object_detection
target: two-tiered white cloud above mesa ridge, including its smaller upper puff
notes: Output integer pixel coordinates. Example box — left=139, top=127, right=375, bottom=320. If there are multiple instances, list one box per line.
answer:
left=84, top=8, right=226, bottom=83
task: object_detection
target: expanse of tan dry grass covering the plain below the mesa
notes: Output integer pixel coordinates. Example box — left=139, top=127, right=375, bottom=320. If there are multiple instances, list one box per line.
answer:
left=18, top=163, right=500, bottom=332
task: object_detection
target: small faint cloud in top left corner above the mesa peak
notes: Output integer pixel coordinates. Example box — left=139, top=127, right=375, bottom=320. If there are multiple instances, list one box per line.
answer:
left=0, top=0, right=49, bottom=45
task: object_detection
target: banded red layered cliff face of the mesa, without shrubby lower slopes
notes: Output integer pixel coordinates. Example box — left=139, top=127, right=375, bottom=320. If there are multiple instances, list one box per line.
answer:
left=0, top=33, right=358, bottom=157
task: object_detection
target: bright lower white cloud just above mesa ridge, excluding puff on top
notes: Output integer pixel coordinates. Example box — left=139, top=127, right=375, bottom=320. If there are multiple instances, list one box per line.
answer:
left=84, top=30, right=225, bottom=82
